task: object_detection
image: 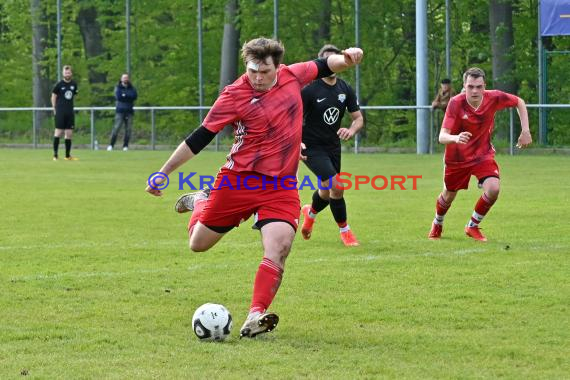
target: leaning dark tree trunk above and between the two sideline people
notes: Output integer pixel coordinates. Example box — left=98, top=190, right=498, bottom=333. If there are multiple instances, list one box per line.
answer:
left=77, top=6, right=107, bottom=92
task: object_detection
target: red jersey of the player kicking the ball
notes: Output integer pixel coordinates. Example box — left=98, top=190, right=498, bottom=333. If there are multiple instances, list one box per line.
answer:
left=202, top=61, right=318, bottom=177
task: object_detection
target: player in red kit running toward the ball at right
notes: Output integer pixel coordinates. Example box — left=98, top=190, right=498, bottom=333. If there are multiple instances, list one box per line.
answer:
left=428, top=67, right=532, bottom=241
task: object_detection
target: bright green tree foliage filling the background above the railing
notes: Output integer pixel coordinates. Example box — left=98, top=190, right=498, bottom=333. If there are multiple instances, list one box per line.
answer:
left=0, top=0, right=570, bottom=145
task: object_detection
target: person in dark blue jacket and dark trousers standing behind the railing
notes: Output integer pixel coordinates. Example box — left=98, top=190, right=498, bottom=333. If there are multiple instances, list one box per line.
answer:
left=107, top=74, right=138, bottom=151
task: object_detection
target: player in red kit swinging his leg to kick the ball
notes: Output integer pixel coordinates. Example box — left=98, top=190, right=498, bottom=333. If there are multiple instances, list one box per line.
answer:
left=146, top=38, right=363, bottom=337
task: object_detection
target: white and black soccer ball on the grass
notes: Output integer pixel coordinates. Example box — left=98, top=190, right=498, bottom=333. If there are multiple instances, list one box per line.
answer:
left=192, top=303, right=232, bottom=341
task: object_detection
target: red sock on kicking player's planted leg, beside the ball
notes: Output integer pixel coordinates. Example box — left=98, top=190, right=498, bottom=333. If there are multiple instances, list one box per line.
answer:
left=249, top=257, right=283, bottom=313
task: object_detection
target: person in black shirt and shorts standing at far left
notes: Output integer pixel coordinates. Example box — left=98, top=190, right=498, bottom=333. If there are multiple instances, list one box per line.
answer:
left=51, top=65, right=78, bottom=161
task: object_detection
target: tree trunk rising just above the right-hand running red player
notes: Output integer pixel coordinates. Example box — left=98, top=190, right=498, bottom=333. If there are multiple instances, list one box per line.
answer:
left=489, top=0, right=517, bottom=93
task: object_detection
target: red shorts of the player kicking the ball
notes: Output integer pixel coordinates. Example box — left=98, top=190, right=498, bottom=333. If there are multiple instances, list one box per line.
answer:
left=199, top=168, right=301, bottom=231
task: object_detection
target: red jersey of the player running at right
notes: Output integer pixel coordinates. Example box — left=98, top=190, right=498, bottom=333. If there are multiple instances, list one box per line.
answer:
left=442, top=90, right=519, bottom=167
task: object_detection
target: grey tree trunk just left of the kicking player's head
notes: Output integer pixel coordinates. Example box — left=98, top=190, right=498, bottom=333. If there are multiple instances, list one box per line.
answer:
left=215, top=0, right=239, bottom=138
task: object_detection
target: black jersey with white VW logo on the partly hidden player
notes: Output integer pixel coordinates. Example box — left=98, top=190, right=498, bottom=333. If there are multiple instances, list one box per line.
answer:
left=301, top=78, right=360, bottom=149
